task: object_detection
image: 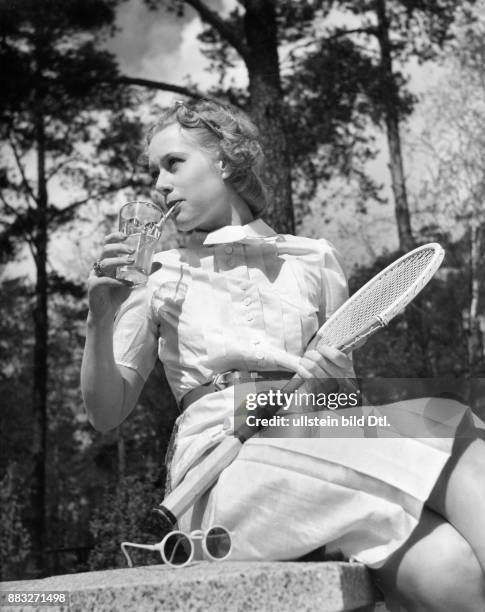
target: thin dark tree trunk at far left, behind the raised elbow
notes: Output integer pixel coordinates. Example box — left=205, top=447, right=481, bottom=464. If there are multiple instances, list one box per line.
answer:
left=30, top=109, right=48, bottom=572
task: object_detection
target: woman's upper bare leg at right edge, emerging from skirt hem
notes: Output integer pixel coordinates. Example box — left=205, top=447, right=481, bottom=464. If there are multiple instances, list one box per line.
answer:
left=426, top=438, right=485, bottom=572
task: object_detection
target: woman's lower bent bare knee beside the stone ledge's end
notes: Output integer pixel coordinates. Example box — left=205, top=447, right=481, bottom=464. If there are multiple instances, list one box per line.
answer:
left=372, top=508, right=485, bottom=612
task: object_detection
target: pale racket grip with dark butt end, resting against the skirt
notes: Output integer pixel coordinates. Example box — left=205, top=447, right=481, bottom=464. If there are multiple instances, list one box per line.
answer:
left=157, top=436, right=242, bottom=524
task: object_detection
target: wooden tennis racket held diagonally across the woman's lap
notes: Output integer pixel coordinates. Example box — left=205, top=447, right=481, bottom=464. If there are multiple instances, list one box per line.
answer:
left=156, top=243, right=445, bottom=526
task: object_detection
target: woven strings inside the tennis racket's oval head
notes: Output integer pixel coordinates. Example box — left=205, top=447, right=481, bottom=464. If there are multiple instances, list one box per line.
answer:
left=319, top=248, right=436, bottom=347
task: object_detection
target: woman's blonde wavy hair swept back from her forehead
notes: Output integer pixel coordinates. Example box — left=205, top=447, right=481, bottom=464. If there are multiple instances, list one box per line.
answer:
left=147, top=100, right=268, bottom=218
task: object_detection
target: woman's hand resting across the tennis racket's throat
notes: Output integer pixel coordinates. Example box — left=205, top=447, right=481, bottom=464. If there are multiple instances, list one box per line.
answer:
left=297, top=342, right=354, bottom=379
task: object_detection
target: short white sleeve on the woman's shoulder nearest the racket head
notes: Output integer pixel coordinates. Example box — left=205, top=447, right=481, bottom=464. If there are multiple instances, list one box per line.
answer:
left=319, top=239, right=349, bottom=319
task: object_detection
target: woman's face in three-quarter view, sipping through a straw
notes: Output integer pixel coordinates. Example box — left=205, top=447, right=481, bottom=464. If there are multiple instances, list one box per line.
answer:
left=148, top=124, right=231, bottom=232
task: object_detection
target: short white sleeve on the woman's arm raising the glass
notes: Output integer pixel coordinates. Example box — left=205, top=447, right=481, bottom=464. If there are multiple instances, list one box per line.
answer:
left=113, top=286, right=159, bottom=380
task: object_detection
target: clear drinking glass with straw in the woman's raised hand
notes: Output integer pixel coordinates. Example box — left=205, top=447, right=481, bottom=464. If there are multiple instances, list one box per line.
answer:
left=116, top=200, right=163, bottom=285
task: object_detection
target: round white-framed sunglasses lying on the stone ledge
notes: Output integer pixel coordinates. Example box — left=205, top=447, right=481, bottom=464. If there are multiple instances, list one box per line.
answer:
left=121, top=525, right=232, bottom=567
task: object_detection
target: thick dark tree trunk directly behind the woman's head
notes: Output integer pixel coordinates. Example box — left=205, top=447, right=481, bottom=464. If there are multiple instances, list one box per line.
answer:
left=244, top=0, right=295, bottom=234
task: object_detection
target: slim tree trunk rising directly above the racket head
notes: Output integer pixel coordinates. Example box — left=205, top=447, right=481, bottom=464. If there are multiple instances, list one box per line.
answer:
left=376, top=0, right=416, bottom=251
